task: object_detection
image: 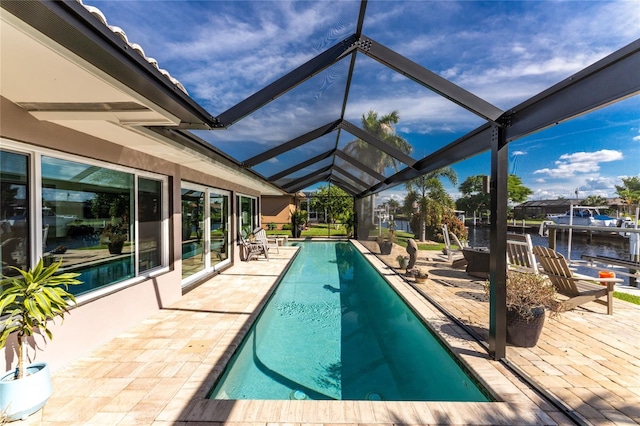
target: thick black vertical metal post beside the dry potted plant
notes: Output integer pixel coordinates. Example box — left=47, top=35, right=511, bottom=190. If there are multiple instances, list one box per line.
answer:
left=489, top=126, right=509, bottom=360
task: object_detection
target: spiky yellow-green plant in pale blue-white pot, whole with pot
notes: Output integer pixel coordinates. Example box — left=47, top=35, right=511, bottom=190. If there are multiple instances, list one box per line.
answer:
left=0, top=259, right=81, bottom=421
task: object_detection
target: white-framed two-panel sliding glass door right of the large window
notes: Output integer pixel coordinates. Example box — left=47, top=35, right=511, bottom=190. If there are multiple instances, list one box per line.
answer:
left=182, top=182, right=229, bottom=284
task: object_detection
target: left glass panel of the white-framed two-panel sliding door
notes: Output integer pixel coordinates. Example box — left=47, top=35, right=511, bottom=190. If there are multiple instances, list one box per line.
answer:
left=182, top=187, right=205, bottom=278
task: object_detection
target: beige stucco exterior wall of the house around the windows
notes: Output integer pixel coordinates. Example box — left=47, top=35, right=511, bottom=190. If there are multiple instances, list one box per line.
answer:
left=0, top=98, right=259, bottom=370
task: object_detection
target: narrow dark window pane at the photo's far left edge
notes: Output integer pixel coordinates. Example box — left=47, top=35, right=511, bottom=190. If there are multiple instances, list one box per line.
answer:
left=0, top=151, right=30, bottom=276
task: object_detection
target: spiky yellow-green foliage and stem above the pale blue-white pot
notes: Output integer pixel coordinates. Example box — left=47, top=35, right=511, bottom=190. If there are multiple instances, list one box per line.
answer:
left=0, top=259, right=82, bottom=379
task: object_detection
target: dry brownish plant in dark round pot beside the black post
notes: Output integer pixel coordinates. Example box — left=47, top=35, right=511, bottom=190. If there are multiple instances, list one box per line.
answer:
left=485, top=271, right=562, bottom=348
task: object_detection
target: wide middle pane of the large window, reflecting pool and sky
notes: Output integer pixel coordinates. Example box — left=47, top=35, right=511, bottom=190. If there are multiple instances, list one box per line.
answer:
left=42, top=156, right=135, bottom=295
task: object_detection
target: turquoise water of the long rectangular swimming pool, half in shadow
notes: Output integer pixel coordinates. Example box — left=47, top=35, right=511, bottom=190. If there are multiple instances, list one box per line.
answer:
left=209, top=242, right=489, bottom=401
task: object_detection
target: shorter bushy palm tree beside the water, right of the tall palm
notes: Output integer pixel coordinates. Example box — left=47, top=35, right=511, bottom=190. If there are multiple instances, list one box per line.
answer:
left=405, top=167, right=458, bottom=241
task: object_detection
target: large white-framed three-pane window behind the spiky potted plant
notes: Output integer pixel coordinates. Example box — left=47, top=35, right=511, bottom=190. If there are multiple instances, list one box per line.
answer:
left=0, top=143, right=168, bottom=295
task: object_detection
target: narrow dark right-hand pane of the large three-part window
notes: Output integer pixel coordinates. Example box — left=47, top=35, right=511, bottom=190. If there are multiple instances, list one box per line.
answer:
left=138, top=178, right=162, bottom=272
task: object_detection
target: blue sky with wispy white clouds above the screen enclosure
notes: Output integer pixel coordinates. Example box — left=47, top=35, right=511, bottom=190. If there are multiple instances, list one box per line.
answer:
left=84, top=0, right=640, bottom=205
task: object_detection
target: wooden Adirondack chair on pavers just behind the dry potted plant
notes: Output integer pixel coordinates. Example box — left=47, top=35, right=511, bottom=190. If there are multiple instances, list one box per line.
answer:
left=533, top=246, right=622, bottom=315
